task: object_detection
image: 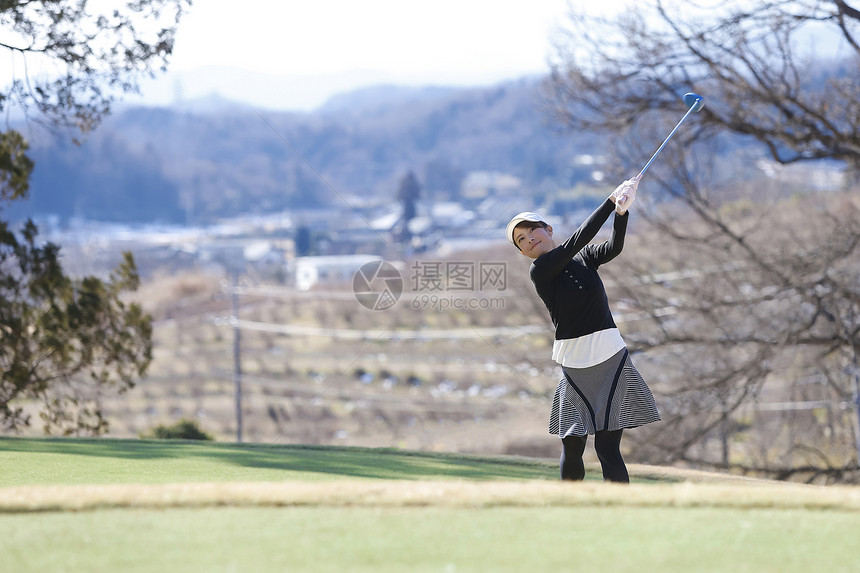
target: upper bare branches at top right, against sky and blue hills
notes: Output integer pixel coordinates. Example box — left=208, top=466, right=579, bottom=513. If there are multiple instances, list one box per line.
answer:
left=550, top=0, right=860, bottom=169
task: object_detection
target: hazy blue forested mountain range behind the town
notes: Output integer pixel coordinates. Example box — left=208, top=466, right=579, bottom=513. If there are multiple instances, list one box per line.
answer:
left=11, top=78, right=593, bottom=223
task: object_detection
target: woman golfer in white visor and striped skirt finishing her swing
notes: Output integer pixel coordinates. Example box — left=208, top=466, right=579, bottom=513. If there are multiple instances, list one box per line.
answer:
left=506, top=179, right=660, bottom=483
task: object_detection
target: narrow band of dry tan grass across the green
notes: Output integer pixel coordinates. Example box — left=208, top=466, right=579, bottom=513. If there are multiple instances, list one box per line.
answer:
left=0, top=474, right=860, bottom=513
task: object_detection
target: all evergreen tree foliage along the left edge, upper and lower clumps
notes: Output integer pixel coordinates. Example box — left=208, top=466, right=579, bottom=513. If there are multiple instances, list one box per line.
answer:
left=0, top=0, right=190, bottom=434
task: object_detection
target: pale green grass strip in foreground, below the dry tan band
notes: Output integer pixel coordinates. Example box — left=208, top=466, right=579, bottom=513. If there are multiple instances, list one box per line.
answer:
left=6, top=507, right=860, bottom=573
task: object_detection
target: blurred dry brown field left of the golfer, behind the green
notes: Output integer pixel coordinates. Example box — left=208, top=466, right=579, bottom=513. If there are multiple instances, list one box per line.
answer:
left=15, top=260, right=572, bottom=457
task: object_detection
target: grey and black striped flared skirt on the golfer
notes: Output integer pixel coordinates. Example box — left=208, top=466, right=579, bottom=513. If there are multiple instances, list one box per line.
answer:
left=549, top=348, right=660, bottom=438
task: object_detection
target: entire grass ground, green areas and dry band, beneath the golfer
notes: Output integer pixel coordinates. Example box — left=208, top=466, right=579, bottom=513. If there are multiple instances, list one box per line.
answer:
left=5, top=438, right=860, bottom=573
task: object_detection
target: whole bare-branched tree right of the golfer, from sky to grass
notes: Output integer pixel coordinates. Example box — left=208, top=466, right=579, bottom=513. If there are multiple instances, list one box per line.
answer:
left=548, top=0, right=860, bottom=481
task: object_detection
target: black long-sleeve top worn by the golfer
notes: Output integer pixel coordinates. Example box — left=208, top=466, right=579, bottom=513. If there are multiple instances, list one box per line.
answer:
left=529, top=199, right=629, bottom=340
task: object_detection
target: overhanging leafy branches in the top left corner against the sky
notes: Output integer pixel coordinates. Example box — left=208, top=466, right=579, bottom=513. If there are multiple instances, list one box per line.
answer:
left=0, top=0, right=191, bottom=133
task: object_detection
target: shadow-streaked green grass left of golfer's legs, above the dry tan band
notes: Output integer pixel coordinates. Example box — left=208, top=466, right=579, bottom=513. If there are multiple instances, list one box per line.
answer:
left=0, top=438, right=560, bottom=487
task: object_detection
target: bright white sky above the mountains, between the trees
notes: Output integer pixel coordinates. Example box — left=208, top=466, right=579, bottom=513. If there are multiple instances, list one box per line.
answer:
left=133, top=0, right=623, bottom=110
